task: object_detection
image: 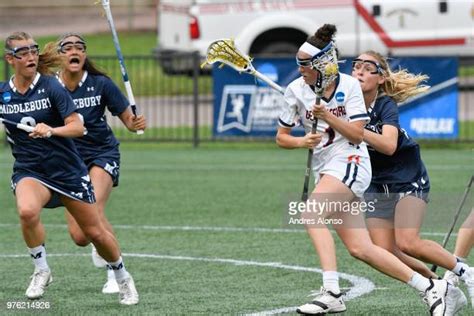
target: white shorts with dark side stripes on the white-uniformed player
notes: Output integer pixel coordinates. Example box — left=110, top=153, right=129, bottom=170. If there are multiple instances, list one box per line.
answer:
left=313, top=145, right=372, bottom=198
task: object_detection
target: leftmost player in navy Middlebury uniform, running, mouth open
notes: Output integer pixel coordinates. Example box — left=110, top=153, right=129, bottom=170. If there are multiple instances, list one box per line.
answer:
left=0, top=32, right=138, bottom=305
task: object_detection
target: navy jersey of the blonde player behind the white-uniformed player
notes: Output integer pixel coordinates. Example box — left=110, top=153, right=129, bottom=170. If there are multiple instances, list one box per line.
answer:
left=365, top=95, right=426, bottom=183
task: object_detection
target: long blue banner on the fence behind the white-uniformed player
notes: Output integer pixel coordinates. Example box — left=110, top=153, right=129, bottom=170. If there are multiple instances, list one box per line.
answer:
left=212, top=57, right=458, bottom=138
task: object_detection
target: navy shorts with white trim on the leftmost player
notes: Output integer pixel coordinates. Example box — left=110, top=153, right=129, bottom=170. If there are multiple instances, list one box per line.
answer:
left=11, top=170, right=95, bottom=208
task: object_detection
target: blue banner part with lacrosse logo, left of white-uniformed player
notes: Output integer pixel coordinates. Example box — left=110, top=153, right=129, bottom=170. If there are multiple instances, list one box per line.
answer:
left=212, top=58, right=303, bottom=137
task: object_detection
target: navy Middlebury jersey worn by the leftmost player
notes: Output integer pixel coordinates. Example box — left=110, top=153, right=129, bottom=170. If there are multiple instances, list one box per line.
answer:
left=0, top=73, right=87, bottom=184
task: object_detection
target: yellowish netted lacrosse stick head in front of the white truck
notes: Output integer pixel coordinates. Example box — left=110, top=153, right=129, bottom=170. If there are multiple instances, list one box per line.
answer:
left=202, top=39, right=255, bottom=73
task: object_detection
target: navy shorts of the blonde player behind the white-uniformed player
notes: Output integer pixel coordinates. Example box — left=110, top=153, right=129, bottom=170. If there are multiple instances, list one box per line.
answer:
left=364, top=172, right=430, bottom=219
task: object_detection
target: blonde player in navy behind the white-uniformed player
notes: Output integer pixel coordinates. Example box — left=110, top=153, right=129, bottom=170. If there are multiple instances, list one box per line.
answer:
left=352, top=51, right=474, bottom=315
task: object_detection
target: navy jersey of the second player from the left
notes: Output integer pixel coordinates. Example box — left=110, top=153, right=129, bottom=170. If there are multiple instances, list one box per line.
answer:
left=57, top=71, right=129, bottom=161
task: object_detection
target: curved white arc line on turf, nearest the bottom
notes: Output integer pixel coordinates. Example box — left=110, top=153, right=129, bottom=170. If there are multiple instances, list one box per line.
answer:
left=0, top=253, right=375, bottom=315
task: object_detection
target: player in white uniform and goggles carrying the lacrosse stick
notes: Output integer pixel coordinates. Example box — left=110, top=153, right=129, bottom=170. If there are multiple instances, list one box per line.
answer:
left=276, top=24, right=450, bottom=315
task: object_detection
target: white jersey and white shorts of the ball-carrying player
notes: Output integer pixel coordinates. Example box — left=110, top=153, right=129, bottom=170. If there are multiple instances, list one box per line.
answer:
left=279, top=74, right=372, bottom=197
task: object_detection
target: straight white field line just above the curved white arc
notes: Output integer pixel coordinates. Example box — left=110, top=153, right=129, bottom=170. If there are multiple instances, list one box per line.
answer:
left=0, top=223, right=457, bottom=236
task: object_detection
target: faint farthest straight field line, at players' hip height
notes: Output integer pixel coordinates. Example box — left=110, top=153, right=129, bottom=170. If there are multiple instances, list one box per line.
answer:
left=0, top=163, right=468, bottom=172
